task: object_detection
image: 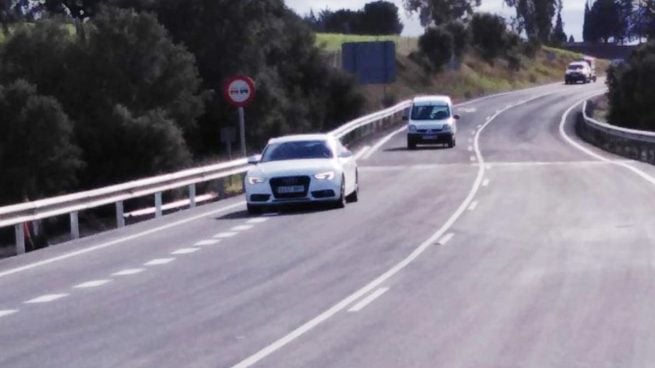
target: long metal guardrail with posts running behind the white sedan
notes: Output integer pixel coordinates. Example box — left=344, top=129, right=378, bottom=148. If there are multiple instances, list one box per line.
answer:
left=0, top=100, right=411, bottom=254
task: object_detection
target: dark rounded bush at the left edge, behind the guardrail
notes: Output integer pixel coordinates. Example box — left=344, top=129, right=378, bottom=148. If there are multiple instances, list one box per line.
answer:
left=0, top=80, right=83, bottom=204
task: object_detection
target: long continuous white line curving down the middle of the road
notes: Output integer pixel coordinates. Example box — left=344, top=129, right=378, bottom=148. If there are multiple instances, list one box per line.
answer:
left=232, top=92, right=555, bottom=368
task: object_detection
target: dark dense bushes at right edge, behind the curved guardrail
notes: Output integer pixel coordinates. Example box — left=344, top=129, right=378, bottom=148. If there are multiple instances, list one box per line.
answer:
left=607, top=42, right=655, bottom=131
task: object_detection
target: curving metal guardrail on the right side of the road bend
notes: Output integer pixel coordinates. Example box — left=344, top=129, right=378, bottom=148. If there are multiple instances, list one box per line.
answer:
left=576, top=101, right=655, bottom=164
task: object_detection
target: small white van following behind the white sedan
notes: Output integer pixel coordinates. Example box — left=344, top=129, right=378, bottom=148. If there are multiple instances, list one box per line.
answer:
left=405, top=96, right=459, bottom=150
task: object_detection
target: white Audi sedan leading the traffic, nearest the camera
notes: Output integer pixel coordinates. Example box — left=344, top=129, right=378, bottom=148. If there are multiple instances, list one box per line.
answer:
left=245, top=134, right=359, bottom=214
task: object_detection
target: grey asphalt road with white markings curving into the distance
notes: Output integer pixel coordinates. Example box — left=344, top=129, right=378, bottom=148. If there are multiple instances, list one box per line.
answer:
left=5, top=83, right=655, bottom=368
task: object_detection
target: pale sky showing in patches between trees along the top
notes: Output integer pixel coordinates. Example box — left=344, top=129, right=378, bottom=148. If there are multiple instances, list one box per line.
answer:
left=285, top=0, right=585, bottom=41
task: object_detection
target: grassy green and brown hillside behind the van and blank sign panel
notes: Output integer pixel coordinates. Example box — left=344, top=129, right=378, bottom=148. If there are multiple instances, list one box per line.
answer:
left=317, top=34, right=608, bottom=110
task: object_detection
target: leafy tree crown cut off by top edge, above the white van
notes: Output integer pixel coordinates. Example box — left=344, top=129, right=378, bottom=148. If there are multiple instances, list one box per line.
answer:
left=403, top=0, right=480, bottom=26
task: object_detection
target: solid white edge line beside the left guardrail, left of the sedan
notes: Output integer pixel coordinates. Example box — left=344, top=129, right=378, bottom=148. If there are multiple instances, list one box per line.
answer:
left=0, top=201, right=246, bottom=278
